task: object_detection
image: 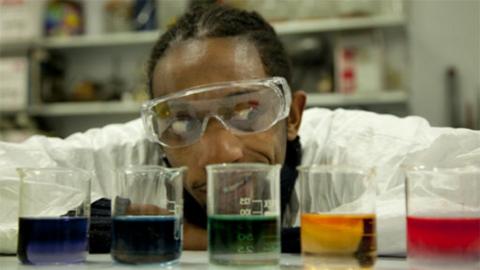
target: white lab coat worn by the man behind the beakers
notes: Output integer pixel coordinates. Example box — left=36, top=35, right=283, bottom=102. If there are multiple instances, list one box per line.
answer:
left=0, top=108, right=480, bottom=254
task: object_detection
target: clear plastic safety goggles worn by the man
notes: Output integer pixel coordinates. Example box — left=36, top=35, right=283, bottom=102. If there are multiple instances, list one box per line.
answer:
left=142, top=77, right=292, bottom=148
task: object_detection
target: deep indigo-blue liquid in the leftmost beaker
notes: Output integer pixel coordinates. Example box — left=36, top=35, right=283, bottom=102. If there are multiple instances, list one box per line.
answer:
left=17, top=217, right=88, bottom=264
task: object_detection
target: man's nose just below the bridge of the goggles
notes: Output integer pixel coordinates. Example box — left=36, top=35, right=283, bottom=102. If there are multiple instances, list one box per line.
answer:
left=199, top=118, right=244, bottom=165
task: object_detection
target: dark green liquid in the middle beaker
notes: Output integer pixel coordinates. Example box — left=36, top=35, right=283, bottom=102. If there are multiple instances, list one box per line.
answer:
left=208, top=215, right=280, bottom=265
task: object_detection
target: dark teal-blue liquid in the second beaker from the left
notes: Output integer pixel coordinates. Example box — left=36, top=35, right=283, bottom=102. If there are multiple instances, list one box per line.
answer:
left=111, top=216, right=182, bottom=264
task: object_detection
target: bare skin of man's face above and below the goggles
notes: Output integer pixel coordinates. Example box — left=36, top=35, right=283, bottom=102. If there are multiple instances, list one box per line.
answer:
left=153, top=38, right=287, bottom=206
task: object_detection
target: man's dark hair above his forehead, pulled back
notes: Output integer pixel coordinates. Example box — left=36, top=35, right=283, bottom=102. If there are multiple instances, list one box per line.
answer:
left=147, top=4, right=292, bottom=97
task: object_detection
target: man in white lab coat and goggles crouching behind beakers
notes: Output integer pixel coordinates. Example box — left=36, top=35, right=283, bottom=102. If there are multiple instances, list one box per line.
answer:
left=0, top=5, right=480, bottom=253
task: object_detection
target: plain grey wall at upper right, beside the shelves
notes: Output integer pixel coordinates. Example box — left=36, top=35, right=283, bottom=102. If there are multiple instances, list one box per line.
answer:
left=407, top=0, right=480, bottom=129
